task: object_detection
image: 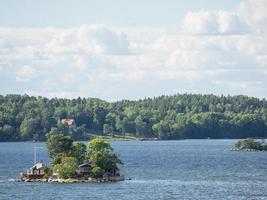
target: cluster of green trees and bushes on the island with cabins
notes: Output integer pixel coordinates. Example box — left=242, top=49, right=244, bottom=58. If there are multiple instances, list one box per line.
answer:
left=45, top=129, right=122, bottom=179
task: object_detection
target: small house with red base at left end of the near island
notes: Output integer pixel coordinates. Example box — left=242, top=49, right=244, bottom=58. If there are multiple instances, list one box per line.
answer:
left=20, top=162, right=45, bottom=180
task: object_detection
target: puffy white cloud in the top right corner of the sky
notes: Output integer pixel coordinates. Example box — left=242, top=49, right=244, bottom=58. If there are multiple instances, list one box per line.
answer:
left=182, top=0, right=267, bottom=34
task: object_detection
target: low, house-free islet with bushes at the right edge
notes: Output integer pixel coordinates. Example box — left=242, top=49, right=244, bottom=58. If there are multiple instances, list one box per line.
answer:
left=232, top=138, right=267, bottom=151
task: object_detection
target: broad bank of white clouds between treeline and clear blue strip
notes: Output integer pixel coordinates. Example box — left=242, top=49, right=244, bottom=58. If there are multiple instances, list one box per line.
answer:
left=0, top=0, right=267, bottom=100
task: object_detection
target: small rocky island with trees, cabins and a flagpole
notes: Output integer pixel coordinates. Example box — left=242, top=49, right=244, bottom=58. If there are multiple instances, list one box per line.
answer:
left=20, top=129, right=124, bottom=183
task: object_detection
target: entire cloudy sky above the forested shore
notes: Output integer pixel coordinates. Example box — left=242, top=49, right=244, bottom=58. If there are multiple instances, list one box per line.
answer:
left=0, top=0, right=267, bottom=101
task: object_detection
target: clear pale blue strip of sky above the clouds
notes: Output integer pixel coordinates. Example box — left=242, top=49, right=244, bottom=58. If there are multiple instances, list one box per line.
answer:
left=0, top=0, right=245, bottom=27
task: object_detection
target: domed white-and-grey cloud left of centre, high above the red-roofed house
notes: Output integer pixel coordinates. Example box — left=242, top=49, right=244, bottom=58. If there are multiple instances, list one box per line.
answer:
left=45, top=25, right=129, bottom=55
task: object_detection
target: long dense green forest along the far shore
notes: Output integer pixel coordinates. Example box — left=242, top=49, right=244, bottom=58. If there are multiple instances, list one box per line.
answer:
left=0, top=94, right=267, bottom=141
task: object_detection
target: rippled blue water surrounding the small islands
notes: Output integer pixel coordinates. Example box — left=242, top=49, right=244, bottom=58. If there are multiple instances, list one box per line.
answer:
left=0, top=140, right=267, bottom=200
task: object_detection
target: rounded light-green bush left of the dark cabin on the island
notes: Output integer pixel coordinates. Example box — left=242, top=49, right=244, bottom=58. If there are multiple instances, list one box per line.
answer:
left=53, top=157, right=78, bottom=179
